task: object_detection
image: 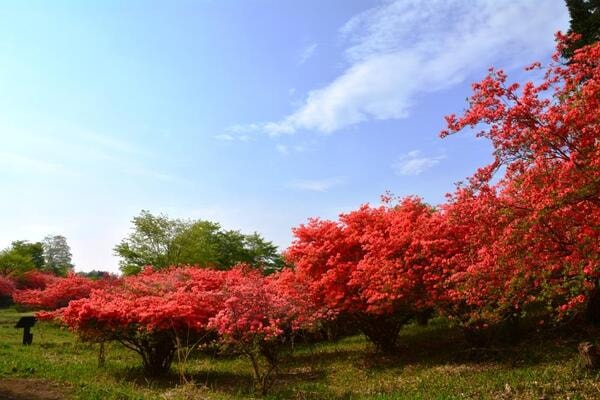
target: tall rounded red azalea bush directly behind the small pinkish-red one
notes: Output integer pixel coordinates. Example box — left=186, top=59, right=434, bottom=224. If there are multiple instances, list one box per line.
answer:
left=286, top=197, right=448, bottom=351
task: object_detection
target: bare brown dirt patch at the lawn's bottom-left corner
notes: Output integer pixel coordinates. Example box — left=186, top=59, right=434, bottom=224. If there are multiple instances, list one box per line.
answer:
left=0, top=378, right=73, bottom=400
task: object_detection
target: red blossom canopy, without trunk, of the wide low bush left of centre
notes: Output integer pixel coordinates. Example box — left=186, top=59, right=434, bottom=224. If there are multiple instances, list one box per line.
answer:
left=58, top=267, right=222, bottom=336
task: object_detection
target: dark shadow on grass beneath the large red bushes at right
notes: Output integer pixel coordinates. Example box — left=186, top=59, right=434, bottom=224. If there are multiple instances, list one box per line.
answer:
left=290, top=321, right=600, bottom=371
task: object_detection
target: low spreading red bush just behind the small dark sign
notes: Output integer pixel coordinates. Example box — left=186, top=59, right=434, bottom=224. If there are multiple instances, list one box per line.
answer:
left=13, top=273, right=110, bottom=310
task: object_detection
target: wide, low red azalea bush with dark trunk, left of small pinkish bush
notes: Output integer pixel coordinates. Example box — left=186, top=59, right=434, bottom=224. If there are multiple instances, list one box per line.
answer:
left=54, top=267, right=225, bottom=375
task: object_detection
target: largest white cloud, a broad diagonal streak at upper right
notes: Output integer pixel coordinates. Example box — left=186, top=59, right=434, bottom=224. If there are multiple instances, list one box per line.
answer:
left=237, top=0, right=568, bottom=136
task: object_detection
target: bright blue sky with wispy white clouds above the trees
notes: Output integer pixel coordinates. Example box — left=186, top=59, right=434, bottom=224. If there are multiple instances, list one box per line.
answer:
left=0, top=0, right=569, bottom=271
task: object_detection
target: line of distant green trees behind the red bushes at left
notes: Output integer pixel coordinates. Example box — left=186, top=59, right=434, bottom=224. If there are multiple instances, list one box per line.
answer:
left=0, top=210, right=284, bottom=279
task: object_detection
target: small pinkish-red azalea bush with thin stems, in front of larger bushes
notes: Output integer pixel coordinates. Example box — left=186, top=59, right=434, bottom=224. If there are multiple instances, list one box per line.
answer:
left=209, top=265, right=319, bottom=394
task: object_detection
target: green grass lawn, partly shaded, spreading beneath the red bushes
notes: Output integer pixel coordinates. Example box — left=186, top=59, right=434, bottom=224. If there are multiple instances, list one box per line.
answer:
left=0, top=309, right=600, bottom=400
